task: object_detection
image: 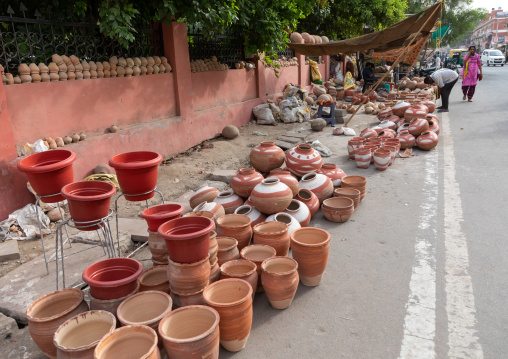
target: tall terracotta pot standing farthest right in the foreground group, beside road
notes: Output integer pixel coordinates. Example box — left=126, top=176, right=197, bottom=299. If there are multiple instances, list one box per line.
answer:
left=291, top=227, right=330, bottom=287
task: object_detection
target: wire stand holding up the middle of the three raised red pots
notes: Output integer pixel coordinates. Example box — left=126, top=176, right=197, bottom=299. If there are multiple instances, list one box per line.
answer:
left=55, top=209, right=116, bottom=290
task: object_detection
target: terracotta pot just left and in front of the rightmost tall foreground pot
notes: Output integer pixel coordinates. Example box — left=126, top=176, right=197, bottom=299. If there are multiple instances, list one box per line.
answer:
left=261, top=257, right=299, bottom=309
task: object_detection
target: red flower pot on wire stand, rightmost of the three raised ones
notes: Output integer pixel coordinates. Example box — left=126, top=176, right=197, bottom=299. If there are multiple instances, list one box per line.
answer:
left=109, top=151, right=162, bottom=202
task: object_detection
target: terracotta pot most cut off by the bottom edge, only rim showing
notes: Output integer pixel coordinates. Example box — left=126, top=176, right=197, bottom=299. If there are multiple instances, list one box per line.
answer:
left=94, top=325, right=161, bottom=359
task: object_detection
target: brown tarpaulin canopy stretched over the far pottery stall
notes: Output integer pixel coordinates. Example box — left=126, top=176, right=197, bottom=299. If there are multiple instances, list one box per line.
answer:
left=288, top=2, right=443, bottom=56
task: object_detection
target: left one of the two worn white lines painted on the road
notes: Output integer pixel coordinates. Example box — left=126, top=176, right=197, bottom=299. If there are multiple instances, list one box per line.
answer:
left=399, top=150, right=439, bottom=359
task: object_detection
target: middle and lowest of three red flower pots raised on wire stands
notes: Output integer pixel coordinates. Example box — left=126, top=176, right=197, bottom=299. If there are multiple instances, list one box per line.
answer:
left=62, top=181, right=116, bottom=231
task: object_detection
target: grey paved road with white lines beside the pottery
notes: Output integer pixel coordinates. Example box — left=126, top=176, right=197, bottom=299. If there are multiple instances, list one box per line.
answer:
left=221, top=67, right=508, bottom=358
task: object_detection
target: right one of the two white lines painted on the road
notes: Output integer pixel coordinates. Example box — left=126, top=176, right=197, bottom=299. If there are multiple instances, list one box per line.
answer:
left=440, top=113, right=483, bottom=359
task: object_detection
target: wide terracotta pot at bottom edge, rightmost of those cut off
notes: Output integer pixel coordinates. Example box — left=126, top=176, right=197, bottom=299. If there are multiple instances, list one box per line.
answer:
left=159, top=305, right=220, bottom=359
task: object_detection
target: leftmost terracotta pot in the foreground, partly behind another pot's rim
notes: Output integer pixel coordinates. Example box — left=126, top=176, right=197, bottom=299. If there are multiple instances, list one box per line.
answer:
left=26, top=288, right=88, bottom=358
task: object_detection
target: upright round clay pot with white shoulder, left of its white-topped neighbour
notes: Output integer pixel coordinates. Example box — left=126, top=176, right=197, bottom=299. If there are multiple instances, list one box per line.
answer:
left=250, top=178, right=293, bottom=214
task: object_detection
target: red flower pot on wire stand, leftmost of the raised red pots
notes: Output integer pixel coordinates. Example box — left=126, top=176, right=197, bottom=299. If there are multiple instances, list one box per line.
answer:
left=18, top=150, right=76, bottom=203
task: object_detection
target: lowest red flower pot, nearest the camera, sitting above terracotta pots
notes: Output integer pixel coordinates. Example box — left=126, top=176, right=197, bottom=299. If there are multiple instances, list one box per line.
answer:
left=83, top=258, right=143, bottom=300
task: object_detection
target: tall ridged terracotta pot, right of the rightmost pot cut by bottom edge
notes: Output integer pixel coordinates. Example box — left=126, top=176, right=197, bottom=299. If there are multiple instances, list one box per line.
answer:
left=203, top=278, right=252, bottom=352
